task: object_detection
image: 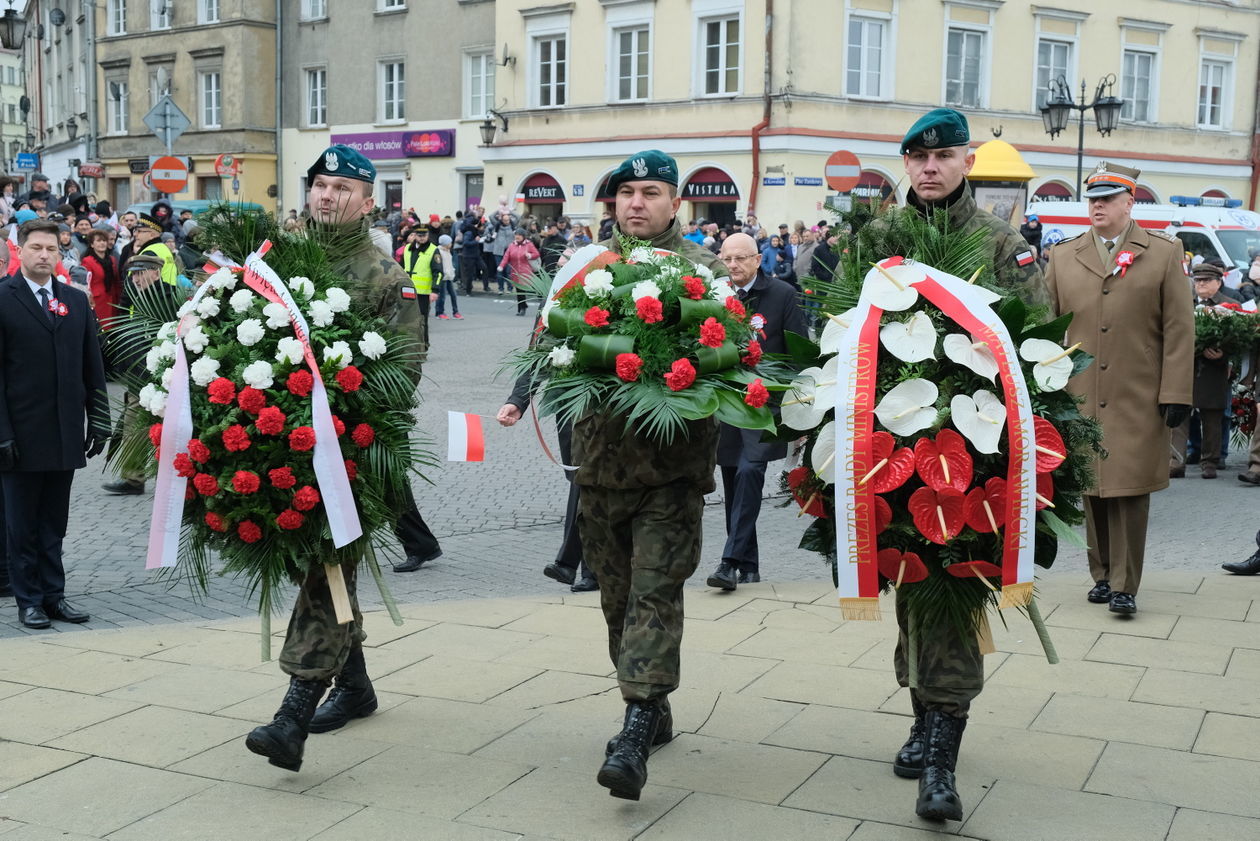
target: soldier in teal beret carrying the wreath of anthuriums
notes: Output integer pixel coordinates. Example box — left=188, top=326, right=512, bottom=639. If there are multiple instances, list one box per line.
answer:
left=892, top=108, right=1048, bottom=821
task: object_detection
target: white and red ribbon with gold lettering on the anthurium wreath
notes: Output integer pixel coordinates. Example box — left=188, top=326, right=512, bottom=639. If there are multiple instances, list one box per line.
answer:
left=834, top=257, right=1037, bottom=619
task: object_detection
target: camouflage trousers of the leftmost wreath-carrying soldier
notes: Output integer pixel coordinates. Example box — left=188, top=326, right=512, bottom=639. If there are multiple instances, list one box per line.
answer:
left=280, top=564, right=367, bottom=683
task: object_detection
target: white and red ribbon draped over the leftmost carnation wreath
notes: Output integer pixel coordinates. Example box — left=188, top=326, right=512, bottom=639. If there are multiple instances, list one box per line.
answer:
left=145, top=241, right=363, bottom=569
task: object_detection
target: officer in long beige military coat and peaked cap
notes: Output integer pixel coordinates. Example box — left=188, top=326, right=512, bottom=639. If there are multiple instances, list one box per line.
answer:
left=1046, top=163, right=1194, bottom=615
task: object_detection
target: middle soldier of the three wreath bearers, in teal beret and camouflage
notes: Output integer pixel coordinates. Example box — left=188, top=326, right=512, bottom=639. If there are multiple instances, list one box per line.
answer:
left=573, top=150, right=726, bottom=801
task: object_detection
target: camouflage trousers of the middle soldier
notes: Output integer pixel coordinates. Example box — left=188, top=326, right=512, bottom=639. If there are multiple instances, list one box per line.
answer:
left=577, top=482, right=704, bottom=701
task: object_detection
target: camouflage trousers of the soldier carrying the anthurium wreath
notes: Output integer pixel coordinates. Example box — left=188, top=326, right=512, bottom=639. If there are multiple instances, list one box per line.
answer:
left=892, top=593, right=984, bottom=719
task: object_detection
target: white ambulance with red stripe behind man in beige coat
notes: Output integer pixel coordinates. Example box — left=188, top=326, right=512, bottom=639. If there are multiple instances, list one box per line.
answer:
left=1026, top=195, right=1260, bottom=269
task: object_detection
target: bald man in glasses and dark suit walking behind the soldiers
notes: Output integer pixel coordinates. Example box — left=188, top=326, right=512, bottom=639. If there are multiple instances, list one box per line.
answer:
left=707, top=233, right=809, bottom=590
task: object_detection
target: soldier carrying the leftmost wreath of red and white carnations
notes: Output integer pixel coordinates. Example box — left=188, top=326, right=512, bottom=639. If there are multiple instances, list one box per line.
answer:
left=246, top=145, right=436, bottom=770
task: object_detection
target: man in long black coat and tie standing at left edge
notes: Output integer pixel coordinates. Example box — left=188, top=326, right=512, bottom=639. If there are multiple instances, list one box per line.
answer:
left=0, top=219, right=110, bottom=628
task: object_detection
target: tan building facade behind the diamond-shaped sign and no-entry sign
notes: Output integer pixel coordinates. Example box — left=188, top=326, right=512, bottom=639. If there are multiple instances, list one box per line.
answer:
left=96, top=0, right=277, bottom=208
